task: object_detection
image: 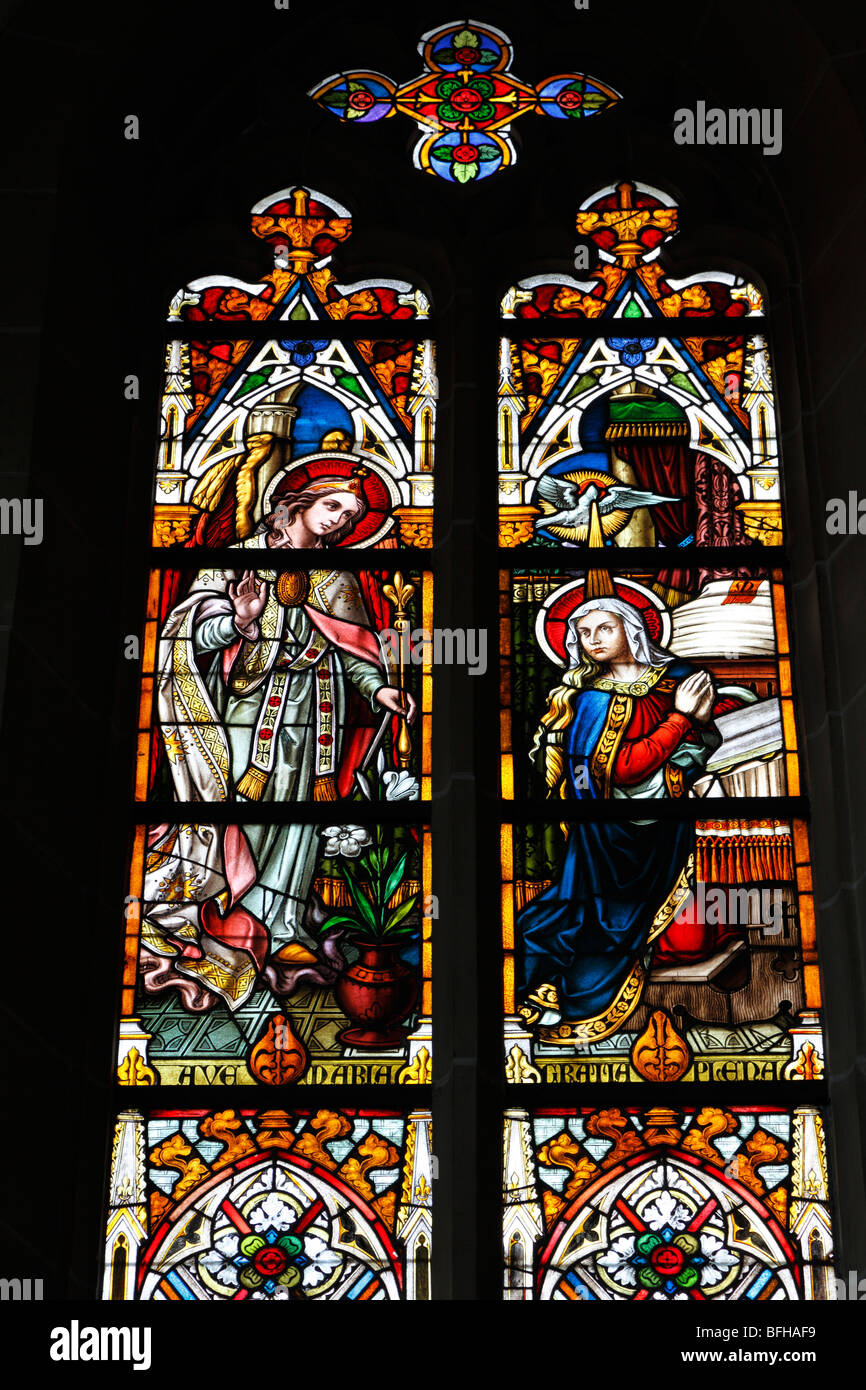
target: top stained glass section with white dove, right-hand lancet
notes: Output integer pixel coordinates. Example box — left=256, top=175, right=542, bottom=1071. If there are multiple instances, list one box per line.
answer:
left=499, top=183, right=783, bottom=549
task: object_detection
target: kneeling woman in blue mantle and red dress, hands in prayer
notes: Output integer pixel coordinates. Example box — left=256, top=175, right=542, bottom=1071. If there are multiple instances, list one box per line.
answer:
left=517, top=589, right=741, bottom=1043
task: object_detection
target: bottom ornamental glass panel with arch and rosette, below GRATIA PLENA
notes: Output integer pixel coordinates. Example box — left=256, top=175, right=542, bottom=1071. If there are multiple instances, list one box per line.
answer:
left=503, top=1105, right=834, bottom=1302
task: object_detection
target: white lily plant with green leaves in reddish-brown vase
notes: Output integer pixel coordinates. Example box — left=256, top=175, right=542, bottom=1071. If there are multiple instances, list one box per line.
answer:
left=320, top=826, right=418, bottom=1051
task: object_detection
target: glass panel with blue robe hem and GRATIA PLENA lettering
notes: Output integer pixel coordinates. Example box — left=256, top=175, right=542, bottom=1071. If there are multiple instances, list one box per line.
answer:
left=502, top=817, right=824, bottom=1083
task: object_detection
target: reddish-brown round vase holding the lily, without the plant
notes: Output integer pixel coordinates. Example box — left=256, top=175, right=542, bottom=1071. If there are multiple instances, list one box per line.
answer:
left=334, top=941, right=418, bottom=1049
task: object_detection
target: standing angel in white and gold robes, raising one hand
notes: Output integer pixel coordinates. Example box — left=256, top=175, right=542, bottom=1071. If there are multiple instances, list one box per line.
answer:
left=142, top=468, right=414, bottom=1009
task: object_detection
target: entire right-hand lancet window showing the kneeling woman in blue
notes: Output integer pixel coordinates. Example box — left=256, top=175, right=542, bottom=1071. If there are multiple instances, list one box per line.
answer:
left=498, top=182, right=834, bottom=1300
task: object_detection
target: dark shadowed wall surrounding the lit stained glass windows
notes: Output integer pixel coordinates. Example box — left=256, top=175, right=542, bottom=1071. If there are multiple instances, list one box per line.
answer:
left=0, top=0, right=866, bottom=1300
